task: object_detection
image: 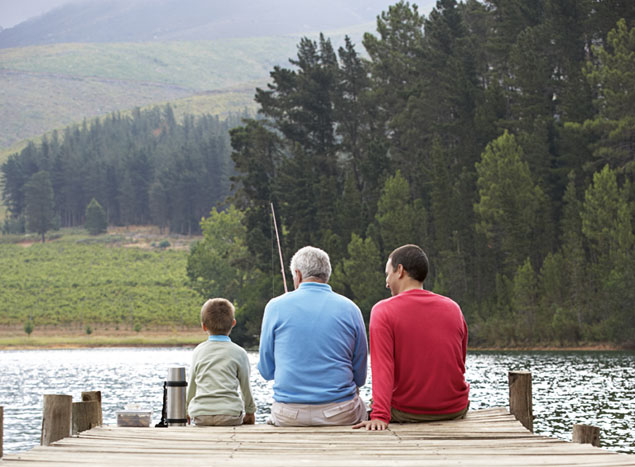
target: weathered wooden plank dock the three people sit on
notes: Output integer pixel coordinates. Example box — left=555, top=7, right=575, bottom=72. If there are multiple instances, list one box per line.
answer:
left=0, top=408, right=635, bottom=467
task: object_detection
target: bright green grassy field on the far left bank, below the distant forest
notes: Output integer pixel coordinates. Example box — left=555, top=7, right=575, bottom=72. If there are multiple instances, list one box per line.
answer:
left=0, top=229, right=201, bottom=332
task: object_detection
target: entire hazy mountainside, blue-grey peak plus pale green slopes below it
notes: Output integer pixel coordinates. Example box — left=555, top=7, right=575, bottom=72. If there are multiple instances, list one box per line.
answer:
left=0, top=0, right=436, bottom=154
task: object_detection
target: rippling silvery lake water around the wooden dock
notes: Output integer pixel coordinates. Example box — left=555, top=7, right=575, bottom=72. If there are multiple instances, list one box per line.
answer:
left=0, top=348, right=635, bottom=453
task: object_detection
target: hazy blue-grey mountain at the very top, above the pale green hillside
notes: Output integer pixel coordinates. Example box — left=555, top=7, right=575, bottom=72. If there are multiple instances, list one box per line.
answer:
left=0, top=0, right=435, bottom=48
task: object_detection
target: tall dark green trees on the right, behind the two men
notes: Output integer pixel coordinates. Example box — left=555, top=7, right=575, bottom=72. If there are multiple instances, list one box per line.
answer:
left=188, top=0, right=635, bottom=346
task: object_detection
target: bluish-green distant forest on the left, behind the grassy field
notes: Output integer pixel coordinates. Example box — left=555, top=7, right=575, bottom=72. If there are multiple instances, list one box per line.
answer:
left=2, top=106, right=240, bottom=234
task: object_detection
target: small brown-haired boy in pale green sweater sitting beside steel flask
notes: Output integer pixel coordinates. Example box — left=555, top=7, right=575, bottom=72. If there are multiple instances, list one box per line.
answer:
left=186, top=298, right=256, bottom=426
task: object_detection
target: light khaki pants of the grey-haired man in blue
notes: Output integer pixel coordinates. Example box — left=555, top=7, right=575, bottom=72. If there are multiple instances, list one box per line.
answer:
left=268, top=394, right=368, bottom=426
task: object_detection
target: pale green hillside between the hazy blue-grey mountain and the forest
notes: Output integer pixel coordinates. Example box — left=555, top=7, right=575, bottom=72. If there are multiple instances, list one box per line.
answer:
left=0, top=37, right=298, bottom=148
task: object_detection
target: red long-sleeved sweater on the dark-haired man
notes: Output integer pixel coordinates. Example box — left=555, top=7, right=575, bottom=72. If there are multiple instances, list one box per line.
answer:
left=370, top=289, right=470, bottom=422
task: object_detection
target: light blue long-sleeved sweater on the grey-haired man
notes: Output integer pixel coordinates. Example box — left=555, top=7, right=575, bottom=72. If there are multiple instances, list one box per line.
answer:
left=258, top=282, right=368, bottom=404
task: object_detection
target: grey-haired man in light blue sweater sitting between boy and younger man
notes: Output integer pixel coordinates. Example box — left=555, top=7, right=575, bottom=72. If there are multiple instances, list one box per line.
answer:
left=258, top=246, right=368, bottom=426
